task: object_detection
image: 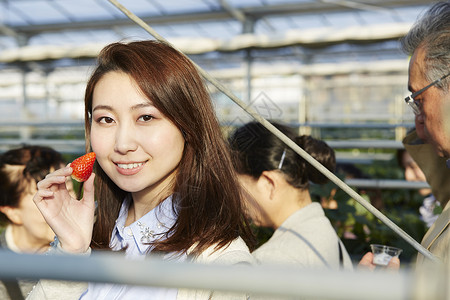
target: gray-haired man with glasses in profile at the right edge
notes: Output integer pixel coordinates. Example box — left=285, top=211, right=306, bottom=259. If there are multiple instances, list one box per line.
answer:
left=401, top=1, right=450, bottom=267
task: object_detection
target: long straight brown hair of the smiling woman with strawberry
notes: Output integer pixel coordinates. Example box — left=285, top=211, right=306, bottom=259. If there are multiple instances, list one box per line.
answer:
left=85, top=41, right=253, bottom=255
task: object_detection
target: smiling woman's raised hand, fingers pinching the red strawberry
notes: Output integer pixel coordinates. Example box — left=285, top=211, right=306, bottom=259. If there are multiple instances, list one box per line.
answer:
left=33, top=166, right=95, bottom=253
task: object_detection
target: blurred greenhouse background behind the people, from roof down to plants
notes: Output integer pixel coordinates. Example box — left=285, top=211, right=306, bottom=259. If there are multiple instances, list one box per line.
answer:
left=0, top=0, right=446, bottom=299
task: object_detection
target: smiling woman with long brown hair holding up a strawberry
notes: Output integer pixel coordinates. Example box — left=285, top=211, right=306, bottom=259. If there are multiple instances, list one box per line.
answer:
left=34, top=41, right=253, bottom=300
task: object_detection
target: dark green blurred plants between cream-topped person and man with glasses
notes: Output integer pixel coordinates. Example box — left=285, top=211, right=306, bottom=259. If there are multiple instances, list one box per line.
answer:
left=311, top=157, right=426, bottom=265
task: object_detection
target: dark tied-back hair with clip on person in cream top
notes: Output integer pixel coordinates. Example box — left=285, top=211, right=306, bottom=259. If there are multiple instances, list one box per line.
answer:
left=229, top=122, right=336, bottom=189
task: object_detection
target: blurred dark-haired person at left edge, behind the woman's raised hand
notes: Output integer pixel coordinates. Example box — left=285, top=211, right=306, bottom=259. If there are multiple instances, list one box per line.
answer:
left=0, top=145, right=71, bottom=299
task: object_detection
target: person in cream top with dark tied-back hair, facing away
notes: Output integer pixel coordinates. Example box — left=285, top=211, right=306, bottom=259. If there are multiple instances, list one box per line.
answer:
left=229, top=122, right=352, bottom=269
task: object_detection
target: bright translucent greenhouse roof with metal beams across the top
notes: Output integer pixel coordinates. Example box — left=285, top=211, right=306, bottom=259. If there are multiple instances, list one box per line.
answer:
left=0, top=0, right=429, bottom=63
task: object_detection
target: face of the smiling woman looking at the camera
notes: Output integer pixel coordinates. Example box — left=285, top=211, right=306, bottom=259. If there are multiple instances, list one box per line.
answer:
left=91, top=71, right=185, bottom=199
